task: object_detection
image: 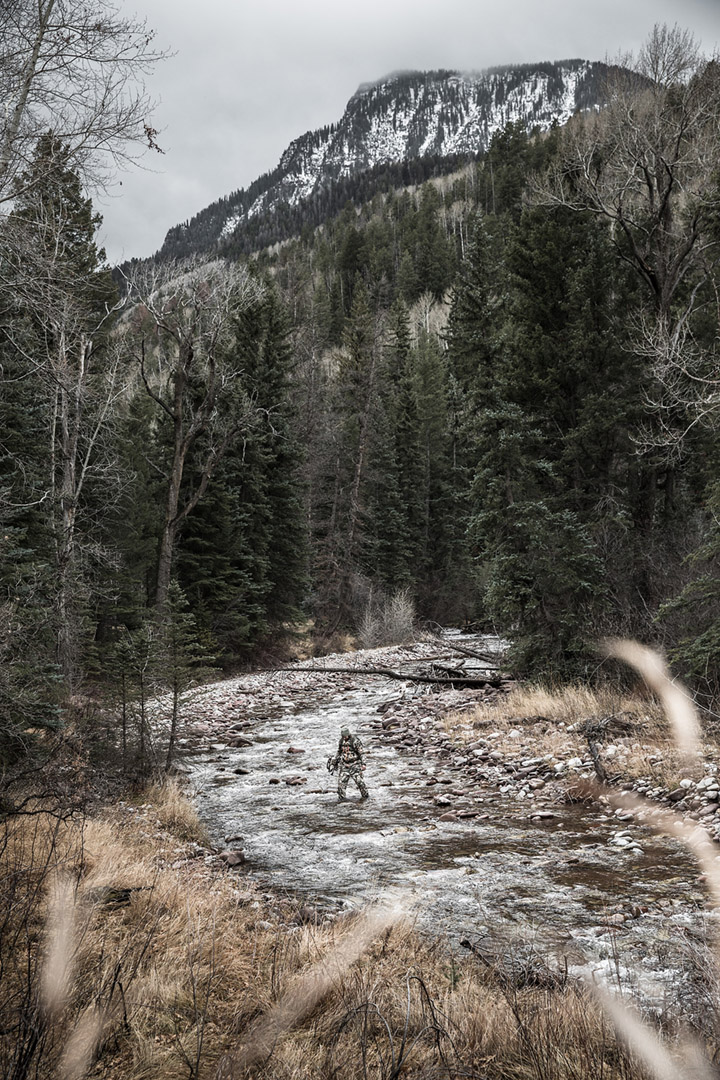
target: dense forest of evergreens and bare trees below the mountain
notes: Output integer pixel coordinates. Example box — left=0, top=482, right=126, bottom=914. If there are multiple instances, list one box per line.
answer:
left=0, top=16, right=720, bottom=766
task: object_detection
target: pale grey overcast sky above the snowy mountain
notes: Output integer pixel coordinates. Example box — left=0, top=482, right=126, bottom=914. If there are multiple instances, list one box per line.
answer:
left=98, top=0, right=720, bottom=262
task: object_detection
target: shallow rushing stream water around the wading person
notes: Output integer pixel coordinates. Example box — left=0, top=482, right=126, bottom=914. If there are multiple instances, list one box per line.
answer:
left=189, top=656, right=705, bottom=1008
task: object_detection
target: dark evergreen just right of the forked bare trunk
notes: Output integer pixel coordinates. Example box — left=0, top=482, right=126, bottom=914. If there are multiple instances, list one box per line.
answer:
left=178, top=286, right=307, bottom=652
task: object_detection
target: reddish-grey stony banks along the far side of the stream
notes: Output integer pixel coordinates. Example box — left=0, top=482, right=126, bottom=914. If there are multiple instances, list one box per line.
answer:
left=172, top=630, right=720, bottom=853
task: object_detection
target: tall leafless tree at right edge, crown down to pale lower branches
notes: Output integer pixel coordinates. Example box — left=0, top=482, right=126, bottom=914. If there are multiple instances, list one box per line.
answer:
left=530, top=26, right=720, bottom=450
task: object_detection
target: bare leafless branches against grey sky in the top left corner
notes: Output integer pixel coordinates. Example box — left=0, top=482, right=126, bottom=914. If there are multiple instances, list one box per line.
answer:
left=0, top=0, right=163, bottom=202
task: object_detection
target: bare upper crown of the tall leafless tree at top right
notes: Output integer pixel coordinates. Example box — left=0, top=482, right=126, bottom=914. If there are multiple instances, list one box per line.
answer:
left=532, top=26, right=720, bottom=321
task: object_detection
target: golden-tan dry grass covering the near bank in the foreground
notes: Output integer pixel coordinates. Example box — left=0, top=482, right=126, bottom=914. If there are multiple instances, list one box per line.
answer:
left=0, top=643, right=720, bottom=1080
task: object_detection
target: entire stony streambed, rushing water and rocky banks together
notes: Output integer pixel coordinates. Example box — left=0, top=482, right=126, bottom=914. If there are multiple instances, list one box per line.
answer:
left=138, top=640, right=720, bottom=1008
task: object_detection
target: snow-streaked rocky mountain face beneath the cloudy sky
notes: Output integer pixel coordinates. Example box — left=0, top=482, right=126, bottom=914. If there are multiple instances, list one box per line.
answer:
left=160, top=59, right=608, bottom=257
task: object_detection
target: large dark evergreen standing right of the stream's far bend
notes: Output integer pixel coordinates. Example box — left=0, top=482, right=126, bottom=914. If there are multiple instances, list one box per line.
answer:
left=473, top=211, right=639, bottom=674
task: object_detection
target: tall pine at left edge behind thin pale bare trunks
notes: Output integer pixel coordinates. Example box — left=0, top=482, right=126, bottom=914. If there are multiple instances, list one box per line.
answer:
left=1, top=133, right=119, bottom=689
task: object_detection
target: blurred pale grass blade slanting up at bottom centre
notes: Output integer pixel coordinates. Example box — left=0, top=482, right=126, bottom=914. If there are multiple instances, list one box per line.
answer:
left=217, top=905, right=405, bottom=1078
